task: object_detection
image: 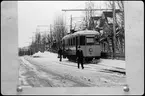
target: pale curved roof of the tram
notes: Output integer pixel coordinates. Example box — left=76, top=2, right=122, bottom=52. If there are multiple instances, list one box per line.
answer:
left=63, top=30, right=99, bottom=39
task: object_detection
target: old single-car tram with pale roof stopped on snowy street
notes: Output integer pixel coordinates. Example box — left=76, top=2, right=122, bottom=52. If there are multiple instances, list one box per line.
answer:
left=62, top=30, right=101, bottom=61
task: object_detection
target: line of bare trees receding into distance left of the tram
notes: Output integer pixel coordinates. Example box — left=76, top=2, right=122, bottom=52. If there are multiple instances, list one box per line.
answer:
left=19, top=15, right=67, bottom=56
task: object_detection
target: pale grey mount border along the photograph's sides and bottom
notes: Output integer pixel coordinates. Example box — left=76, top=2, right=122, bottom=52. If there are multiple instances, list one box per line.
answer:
left=1, top=1, right=144, bottom=95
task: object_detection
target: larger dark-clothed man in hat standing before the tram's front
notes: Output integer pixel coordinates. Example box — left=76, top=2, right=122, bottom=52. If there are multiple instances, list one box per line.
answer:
left=76, top=46, right=84, bottom=69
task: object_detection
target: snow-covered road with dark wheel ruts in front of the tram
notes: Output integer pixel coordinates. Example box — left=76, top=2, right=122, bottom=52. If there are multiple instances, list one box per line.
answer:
left=19, top=52, right=126, bottom=87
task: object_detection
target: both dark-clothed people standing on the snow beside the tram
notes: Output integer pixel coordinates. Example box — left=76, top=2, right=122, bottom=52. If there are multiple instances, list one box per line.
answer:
left=58, top=46, right=84, bottom=69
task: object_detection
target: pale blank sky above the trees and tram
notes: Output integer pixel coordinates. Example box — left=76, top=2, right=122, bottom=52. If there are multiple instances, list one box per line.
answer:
left=18, top=1, right=105, bottom=47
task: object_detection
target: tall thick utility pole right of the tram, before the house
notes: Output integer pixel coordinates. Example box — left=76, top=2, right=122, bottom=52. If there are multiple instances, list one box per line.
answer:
left=112, top=1, right=116, bottom=59
